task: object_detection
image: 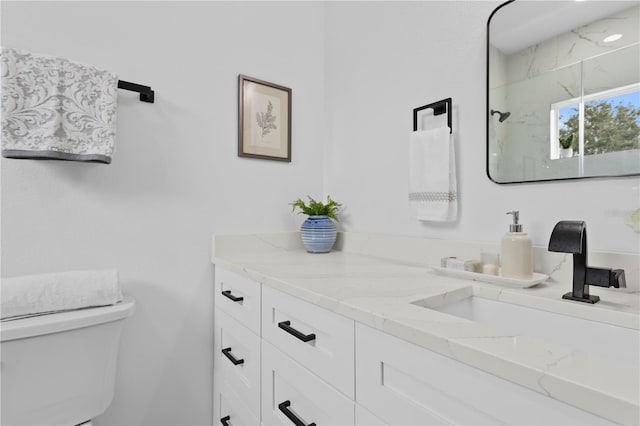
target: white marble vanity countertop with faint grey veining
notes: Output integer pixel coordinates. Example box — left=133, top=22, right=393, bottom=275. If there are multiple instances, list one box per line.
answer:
left=212, top=233, right=640, bottom=425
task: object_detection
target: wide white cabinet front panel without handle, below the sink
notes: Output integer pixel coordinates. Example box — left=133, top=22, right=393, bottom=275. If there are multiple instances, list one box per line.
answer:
left=356, top=324, right=609, bottom=425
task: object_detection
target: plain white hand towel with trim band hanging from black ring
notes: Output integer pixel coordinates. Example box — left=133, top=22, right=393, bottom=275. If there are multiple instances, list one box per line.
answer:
left=409, top=127, right=458, bottom=222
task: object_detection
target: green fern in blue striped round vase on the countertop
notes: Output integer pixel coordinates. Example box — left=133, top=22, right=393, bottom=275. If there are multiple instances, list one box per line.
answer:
left=290, top=195, right=342, bottom=253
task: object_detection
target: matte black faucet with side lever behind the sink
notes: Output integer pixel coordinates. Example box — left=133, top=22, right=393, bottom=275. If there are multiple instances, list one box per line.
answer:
left=549, top=220, right=627, bottom=303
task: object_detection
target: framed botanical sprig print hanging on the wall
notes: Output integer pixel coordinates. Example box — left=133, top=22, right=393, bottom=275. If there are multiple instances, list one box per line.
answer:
left=238, top=75, right=291, bottom=162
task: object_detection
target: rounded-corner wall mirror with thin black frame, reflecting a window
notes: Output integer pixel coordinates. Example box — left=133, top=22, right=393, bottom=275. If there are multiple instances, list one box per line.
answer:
left=487, top=0, right=640, bottom=183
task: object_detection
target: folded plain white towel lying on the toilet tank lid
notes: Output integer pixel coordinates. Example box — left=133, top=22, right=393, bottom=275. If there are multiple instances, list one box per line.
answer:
left=0, top=270, right=123, bottom=321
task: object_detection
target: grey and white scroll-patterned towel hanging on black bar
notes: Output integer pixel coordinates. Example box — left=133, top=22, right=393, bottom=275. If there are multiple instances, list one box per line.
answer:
left=2, top=48, right=118, bottom=164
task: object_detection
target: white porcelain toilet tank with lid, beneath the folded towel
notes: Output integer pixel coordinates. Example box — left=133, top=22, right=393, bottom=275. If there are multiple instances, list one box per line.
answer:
left=0, top=297, right=135, bottom=426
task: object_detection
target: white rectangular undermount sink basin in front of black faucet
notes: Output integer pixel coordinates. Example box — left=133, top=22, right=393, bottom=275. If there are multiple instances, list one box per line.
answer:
left=413, top=295, right=640, bottom=365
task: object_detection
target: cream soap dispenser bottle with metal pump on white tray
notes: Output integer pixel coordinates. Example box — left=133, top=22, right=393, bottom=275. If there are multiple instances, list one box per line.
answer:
left=501, top=211, right=533, bottom=280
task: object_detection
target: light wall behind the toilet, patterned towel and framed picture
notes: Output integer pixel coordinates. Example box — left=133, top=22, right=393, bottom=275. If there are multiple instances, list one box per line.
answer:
left=1, top=1, right=324, bottom=425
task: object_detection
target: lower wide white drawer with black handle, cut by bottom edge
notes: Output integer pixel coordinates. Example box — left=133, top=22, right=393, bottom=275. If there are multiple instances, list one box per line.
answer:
left=262, top=340, right=354, bottom=426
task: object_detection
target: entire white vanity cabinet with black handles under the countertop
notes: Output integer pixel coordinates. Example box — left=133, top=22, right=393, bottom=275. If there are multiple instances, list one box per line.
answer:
left=214, top=267, right=611, bottom=426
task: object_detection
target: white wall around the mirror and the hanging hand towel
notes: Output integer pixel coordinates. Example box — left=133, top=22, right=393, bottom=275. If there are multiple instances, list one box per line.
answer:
left=325, top=1, right=640, bottom=255
